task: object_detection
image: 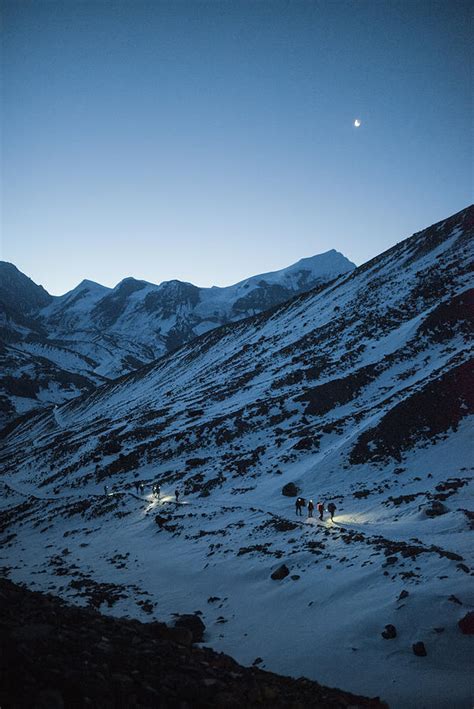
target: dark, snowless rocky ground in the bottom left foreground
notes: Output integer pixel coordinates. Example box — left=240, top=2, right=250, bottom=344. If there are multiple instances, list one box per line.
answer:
left=0, top=579, right=386, bottom=709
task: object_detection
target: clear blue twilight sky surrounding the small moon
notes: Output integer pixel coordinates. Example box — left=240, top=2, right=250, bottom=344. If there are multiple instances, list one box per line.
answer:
left=0, top=0, right=473, bottom=295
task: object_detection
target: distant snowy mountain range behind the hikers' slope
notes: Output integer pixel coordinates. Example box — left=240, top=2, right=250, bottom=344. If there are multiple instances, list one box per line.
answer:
left=0, top=251, right=354, bottom=426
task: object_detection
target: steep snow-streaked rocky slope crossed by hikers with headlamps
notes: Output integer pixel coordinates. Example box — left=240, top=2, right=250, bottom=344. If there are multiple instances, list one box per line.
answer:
left=0, top=207, right=474, bottom=709
